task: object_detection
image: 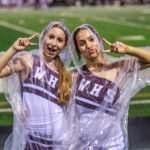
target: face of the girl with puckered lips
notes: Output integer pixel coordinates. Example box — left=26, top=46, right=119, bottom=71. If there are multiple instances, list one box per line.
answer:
left=76, top=29, right=100, bottom=59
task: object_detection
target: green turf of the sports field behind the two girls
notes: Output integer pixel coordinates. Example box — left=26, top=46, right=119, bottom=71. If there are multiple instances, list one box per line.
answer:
left=0, top=6, right=150, bottom=125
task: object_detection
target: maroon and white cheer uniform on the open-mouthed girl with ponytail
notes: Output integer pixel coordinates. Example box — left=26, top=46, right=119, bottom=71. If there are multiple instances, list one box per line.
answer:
left=21, top=56, right=65, bottom=150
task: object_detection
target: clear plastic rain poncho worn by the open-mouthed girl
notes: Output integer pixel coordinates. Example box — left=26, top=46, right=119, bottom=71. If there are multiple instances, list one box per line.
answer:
left=2, top=22, right=75, bottom=150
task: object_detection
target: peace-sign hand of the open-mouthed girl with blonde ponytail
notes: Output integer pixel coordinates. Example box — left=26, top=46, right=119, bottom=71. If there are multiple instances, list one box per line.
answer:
left=12, top=33, right=38, bottom=52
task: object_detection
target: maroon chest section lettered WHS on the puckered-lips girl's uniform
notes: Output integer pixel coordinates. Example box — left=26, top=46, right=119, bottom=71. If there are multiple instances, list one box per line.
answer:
left=76, top=65, right=120, bottom=115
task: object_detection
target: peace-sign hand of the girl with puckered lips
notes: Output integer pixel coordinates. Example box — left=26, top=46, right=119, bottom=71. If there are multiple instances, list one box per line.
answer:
left=102, top=38, right=128, bottom=54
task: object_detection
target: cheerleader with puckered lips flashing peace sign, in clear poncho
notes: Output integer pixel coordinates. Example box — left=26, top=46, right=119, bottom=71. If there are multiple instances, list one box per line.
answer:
left=72, top=24, right=150, bottom=150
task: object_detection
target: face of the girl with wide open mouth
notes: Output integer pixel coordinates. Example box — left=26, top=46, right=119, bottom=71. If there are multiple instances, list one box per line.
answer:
left=43, top=27, right=66, bottom=58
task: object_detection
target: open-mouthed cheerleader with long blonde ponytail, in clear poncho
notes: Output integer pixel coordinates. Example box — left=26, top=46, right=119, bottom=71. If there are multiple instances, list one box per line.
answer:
left=0, top=22, right=71, bottom=150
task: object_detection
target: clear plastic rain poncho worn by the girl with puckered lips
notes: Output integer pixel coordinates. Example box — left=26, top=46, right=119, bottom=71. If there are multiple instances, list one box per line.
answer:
left=71, top=24, right=150, bottom=150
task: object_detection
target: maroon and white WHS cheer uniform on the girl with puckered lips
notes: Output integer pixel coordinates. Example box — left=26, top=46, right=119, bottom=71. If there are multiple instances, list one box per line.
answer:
left=76, top=65, right=124, bottom=150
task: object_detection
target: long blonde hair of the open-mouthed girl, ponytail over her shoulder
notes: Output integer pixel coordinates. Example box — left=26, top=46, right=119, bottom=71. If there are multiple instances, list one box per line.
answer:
left=39, top=22, right=72, bottom=105
